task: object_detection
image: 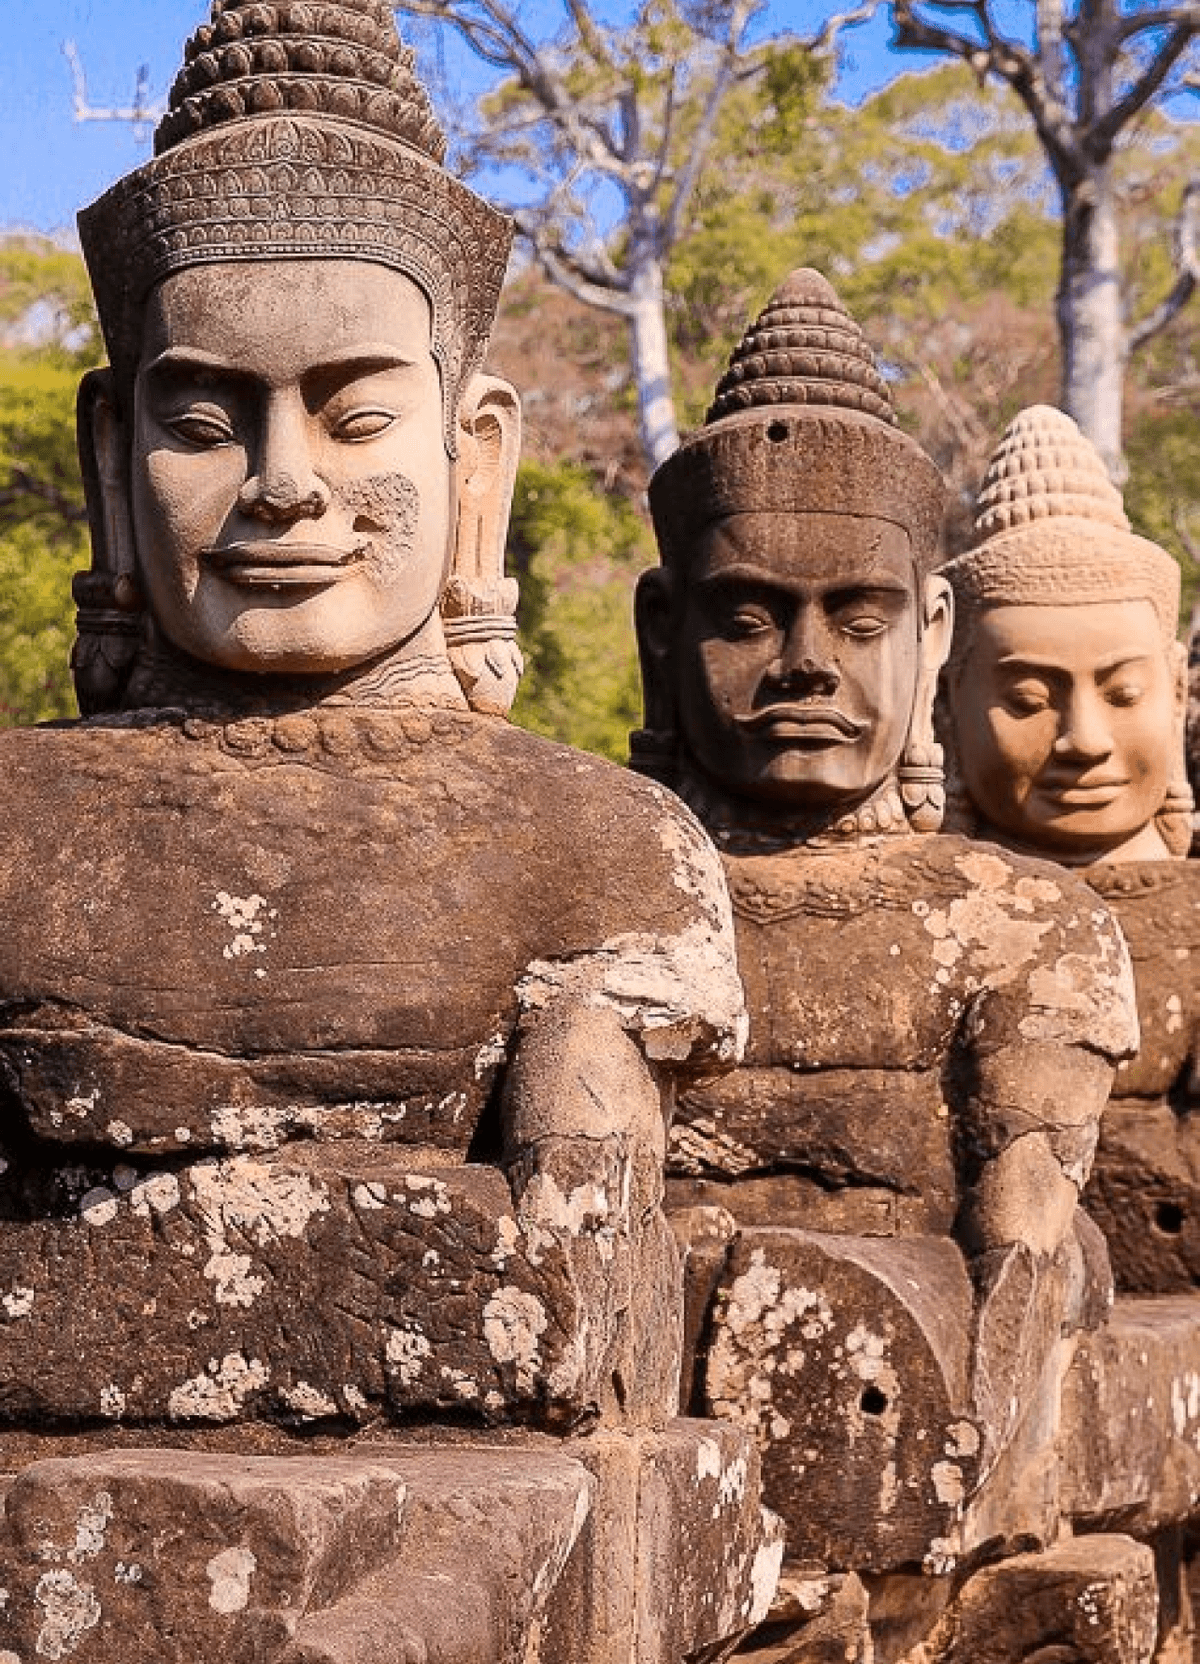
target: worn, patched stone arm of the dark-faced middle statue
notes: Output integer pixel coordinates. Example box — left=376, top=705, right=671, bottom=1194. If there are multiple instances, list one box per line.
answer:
left=955, top=915, right=1137, bottom=1468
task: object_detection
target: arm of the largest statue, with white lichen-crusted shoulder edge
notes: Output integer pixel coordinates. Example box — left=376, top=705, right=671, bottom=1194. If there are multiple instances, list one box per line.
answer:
left=503, top=810, right=746, bottom=1421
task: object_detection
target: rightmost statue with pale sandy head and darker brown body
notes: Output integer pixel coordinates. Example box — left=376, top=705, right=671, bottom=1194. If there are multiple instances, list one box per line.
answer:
left=945, top=406, right=1200, bottom=1293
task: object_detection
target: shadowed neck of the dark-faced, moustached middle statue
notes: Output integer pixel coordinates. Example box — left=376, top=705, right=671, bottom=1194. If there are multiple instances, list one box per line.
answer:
left=676, top=764, right=912, bottom=855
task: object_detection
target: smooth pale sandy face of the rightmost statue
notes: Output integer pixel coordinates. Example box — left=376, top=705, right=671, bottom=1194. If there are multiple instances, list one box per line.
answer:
left=950, top=601, right=1177, bottom=862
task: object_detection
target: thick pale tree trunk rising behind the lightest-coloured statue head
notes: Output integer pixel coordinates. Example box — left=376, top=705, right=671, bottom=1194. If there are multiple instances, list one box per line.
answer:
left=1055, top=166, right=1128, bottom=484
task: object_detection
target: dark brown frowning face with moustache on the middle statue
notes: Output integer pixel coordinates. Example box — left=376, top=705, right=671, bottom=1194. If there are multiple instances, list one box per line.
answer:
left=674, top=513, right=920, bottom=809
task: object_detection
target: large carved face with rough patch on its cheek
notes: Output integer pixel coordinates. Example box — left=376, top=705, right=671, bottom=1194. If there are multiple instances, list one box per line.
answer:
left=131, top=260, right=453, bottom=672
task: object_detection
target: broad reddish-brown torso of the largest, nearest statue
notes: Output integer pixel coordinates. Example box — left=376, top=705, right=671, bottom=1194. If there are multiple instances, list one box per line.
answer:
left=0, top=709, right=712, bottom=1156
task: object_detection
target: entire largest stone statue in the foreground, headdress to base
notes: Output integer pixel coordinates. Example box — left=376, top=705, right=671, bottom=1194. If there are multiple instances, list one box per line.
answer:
left=0, top=0, right=772, bottom=1664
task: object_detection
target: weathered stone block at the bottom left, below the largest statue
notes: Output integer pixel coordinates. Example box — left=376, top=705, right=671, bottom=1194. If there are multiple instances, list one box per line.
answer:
left=0, top=1448, right=594, bottom=1664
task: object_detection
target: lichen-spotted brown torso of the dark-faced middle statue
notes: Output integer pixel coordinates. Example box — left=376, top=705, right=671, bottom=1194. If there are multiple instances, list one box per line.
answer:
left=674, top=837, right=1130, bottom=1235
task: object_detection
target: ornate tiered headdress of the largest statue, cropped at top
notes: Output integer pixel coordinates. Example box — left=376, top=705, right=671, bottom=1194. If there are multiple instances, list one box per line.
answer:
left=80, top=0, right=511, bottom=453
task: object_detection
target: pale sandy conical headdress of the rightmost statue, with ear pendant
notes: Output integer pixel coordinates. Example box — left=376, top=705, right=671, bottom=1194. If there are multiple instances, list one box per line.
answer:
left=944, top=404, right=1193, bottom=854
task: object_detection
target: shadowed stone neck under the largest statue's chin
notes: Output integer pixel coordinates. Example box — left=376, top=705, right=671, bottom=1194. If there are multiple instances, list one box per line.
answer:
left=121, top=624, right=468, bottom=717
